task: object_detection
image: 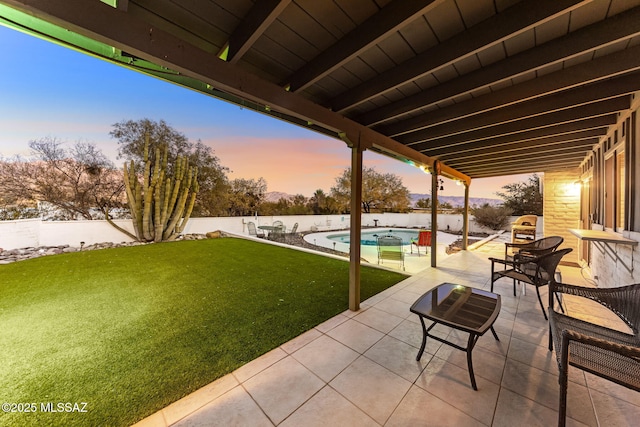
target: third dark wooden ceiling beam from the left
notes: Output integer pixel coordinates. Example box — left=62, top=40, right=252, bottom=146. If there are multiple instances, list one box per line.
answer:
left=328, top=0, right=583, bottom=112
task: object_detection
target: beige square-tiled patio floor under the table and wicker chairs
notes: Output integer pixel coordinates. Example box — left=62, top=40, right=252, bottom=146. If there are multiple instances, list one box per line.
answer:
left=136, top=236, right=640, bottom=427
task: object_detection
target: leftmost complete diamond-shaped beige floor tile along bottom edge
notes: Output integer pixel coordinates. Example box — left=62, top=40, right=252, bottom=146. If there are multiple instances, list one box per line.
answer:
left=243, top=357, right=325, bottom=424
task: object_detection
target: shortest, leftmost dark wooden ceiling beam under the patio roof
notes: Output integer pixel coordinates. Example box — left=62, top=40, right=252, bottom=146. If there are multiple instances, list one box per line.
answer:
left=227, top=0, right=291, bottom=63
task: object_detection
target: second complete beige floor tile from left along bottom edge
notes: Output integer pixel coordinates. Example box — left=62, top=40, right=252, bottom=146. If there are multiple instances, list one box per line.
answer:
left=329, top=357, right=411, bottom=424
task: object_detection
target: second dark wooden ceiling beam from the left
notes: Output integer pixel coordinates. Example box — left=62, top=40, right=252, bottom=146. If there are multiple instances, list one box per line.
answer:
left=282, top=0, right=438, bottom=92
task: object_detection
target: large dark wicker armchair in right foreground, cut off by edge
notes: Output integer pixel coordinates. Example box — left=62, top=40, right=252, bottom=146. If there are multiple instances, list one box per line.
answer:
left=549, top=283, right=640, bottom=426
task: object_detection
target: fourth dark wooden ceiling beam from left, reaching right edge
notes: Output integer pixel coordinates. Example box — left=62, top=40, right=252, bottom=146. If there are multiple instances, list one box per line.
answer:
left=356, top=7, right=640, bottom=124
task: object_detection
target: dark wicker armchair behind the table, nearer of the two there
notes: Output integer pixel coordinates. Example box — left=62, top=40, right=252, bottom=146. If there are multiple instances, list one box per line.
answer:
left=489, top=248, right=573, bottom=320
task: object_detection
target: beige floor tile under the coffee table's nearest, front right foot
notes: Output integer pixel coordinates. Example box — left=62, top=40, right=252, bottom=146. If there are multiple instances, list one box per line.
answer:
left=416, top=357, right=500, bottom=425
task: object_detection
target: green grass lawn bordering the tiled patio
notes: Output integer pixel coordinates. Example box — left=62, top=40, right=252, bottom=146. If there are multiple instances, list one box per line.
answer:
left=0, top=238, right=405, bottom=427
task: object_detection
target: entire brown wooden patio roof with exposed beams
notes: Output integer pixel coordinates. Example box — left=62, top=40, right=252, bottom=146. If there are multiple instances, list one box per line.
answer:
left=0, top=0, right=640, bottom=184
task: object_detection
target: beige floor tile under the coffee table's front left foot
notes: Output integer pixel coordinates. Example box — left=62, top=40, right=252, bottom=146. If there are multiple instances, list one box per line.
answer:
left=364, top=336, right=431, bottom=382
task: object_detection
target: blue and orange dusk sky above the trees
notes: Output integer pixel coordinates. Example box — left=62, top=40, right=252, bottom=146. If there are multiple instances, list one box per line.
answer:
left=0, top=26, right=528, bottom=199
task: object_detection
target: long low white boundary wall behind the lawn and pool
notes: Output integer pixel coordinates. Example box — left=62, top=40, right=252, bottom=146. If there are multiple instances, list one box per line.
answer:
left=0, top=212, right=543, bottom=250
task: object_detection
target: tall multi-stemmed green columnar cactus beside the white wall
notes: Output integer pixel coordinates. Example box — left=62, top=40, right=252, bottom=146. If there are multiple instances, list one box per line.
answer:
left=124, top=135, right=198, bottom=242
